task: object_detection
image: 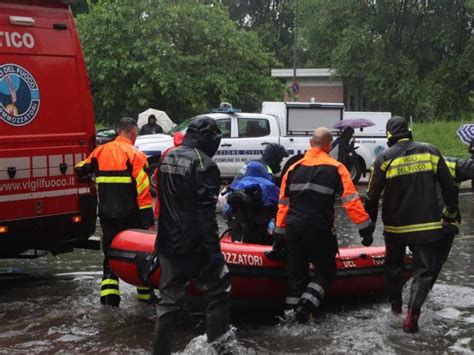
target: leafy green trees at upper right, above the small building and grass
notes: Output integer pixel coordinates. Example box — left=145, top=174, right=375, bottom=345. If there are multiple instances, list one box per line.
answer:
left=301, top=0, right=474, bottom=119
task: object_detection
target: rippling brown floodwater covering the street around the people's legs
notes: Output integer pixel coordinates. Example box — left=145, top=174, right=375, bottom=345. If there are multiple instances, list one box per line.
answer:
left=0, top=194, right=474, bottom=354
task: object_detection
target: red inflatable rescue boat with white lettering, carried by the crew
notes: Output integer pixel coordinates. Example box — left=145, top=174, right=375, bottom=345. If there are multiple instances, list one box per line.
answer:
left=109, top=229, right=412, bottom=304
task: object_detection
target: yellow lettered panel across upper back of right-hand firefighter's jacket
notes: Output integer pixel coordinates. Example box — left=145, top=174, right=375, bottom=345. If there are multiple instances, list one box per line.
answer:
left=381, top=153, right=439, bottom=179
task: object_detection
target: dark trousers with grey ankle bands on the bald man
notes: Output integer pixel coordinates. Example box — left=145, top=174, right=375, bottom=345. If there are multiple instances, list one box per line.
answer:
left=285, top=225, right=338, bottom=313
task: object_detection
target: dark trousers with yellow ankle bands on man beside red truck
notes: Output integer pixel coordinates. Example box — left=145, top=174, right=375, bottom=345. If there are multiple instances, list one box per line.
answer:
left=100, top=218, right=153, bottom=307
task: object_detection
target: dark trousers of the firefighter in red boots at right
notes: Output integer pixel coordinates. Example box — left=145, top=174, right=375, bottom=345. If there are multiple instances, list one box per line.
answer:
left=385, top=237, right=439, bottom=315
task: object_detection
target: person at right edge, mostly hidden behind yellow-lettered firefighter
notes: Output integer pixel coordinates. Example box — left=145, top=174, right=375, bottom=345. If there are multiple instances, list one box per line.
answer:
left=431, top=158, right=474, bottom=287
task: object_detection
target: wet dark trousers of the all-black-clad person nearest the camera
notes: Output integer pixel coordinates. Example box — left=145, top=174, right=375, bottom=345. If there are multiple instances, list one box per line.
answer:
left=153, top=253, right=231, bottom=355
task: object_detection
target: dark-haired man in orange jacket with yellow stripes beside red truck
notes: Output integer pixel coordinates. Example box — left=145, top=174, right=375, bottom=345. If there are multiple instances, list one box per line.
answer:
left=76, top=117, right=156, bottom=307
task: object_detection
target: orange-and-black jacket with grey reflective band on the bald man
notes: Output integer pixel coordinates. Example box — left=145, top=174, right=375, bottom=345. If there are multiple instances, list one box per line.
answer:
left=275, top=148, right=371, bottom=234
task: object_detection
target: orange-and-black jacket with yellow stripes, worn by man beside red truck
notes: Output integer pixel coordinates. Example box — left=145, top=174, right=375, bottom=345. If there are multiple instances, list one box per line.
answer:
left=76, top=136, right=153, bottom=218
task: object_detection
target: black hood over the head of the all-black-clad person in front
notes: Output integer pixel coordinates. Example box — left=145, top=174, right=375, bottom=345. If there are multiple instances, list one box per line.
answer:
left=183, top=115, right=222, bottom=158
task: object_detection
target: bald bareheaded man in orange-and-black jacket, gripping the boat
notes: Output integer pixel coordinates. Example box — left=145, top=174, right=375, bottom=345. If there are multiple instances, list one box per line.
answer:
left=267, top=128, right=374, bottom=323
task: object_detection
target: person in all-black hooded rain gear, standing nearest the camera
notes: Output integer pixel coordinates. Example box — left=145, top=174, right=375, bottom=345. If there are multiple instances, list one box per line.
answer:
left=153, top=116, right=230, bottom=354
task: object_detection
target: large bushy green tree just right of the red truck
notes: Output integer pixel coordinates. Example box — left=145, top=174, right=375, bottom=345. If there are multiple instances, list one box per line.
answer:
left=77, top=0, right=282, bottom=122
